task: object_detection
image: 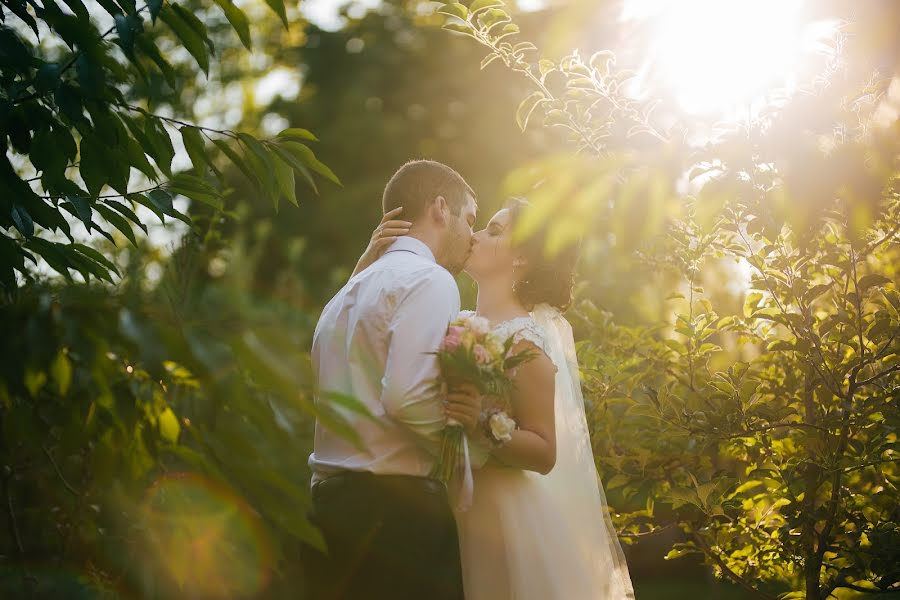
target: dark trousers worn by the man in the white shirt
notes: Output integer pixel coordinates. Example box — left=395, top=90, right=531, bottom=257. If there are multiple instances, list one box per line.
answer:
left=306, top=472, right=463, bottom=600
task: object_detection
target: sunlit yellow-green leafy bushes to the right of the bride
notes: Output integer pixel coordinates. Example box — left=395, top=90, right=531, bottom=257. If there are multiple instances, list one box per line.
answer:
left=440, top=2, right=900, bottom=599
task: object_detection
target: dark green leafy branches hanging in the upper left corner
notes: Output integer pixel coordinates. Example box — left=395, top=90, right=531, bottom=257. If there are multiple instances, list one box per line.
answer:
left=0, top=0, right=338, bottom=293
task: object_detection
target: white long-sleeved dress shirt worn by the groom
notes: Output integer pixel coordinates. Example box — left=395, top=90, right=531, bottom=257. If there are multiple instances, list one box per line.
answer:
left=309, top=237, right=459, bottom=484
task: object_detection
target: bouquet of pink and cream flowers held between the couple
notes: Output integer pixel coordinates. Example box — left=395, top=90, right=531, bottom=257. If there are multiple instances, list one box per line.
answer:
left=431, top=315, right=534, bottom=485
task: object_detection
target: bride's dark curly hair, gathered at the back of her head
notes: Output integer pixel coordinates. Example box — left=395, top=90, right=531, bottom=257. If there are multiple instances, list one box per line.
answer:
left=507, top=198, right=581, bottom=311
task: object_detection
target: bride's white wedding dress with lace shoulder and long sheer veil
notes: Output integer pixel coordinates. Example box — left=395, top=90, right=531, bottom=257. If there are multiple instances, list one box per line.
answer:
left=456, top=305, right=634, bottom=600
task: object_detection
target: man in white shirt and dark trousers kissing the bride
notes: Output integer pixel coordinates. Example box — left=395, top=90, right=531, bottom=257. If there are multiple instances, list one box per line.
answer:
left=309, top=160, right=480, bottom=600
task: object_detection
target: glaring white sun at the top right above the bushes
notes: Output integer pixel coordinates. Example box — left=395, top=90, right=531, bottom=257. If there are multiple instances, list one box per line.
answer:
left=622, top=0, right=825, bottom=116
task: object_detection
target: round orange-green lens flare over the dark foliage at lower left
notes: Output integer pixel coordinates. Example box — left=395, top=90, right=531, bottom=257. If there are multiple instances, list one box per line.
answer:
left=141, top=473, right=272, bottom=598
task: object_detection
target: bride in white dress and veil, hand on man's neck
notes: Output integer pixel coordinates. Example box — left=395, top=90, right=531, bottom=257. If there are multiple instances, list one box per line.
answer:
left=356, top=199, right=634, bottom=600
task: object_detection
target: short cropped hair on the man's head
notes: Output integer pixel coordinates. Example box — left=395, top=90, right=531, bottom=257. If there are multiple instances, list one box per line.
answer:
left=381, top=160, right=475, bottom=221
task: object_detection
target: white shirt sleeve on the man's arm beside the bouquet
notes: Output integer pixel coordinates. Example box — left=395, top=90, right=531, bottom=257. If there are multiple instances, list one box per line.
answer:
left=381, top=270, right=459, bottom=443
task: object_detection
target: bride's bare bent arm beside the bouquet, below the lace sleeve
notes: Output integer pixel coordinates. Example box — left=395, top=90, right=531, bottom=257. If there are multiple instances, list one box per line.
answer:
left=492, top=342, right=556, bottom=475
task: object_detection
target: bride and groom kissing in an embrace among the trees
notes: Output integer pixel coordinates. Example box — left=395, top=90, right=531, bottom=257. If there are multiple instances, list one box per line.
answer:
left=306, top=160, right=634, bottom=600
